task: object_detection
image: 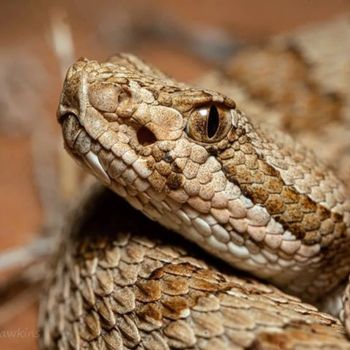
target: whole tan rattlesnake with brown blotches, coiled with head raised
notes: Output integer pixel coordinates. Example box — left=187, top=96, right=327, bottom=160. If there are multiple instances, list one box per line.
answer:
left=41, top=15, right=350, bottom=349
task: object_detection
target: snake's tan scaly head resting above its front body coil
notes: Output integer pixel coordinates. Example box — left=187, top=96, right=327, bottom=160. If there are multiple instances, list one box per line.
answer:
left=58, top=54, right=350, bottom=306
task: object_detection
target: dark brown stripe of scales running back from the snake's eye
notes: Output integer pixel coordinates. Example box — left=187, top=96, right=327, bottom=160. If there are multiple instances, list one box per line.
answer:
left=219, top=135, right=345, bottom=245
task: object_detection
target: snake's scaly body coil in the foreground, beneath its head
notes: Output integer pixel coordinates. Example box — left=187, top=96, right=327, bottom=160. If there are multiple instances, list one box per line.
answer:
left=39, top=187, right=350, bottom=350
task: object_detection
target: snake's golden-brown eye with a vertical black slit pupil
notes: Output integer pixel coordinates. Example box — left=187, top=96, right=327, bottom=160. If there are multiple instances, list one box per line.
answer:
left=187, top=105, right=232, bottom=143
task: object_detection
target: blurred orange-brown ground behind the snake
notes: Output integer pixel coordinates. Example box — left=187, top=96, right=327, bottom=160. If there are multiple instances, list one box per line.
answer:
left=0, top=0, right=350, bottom=350
